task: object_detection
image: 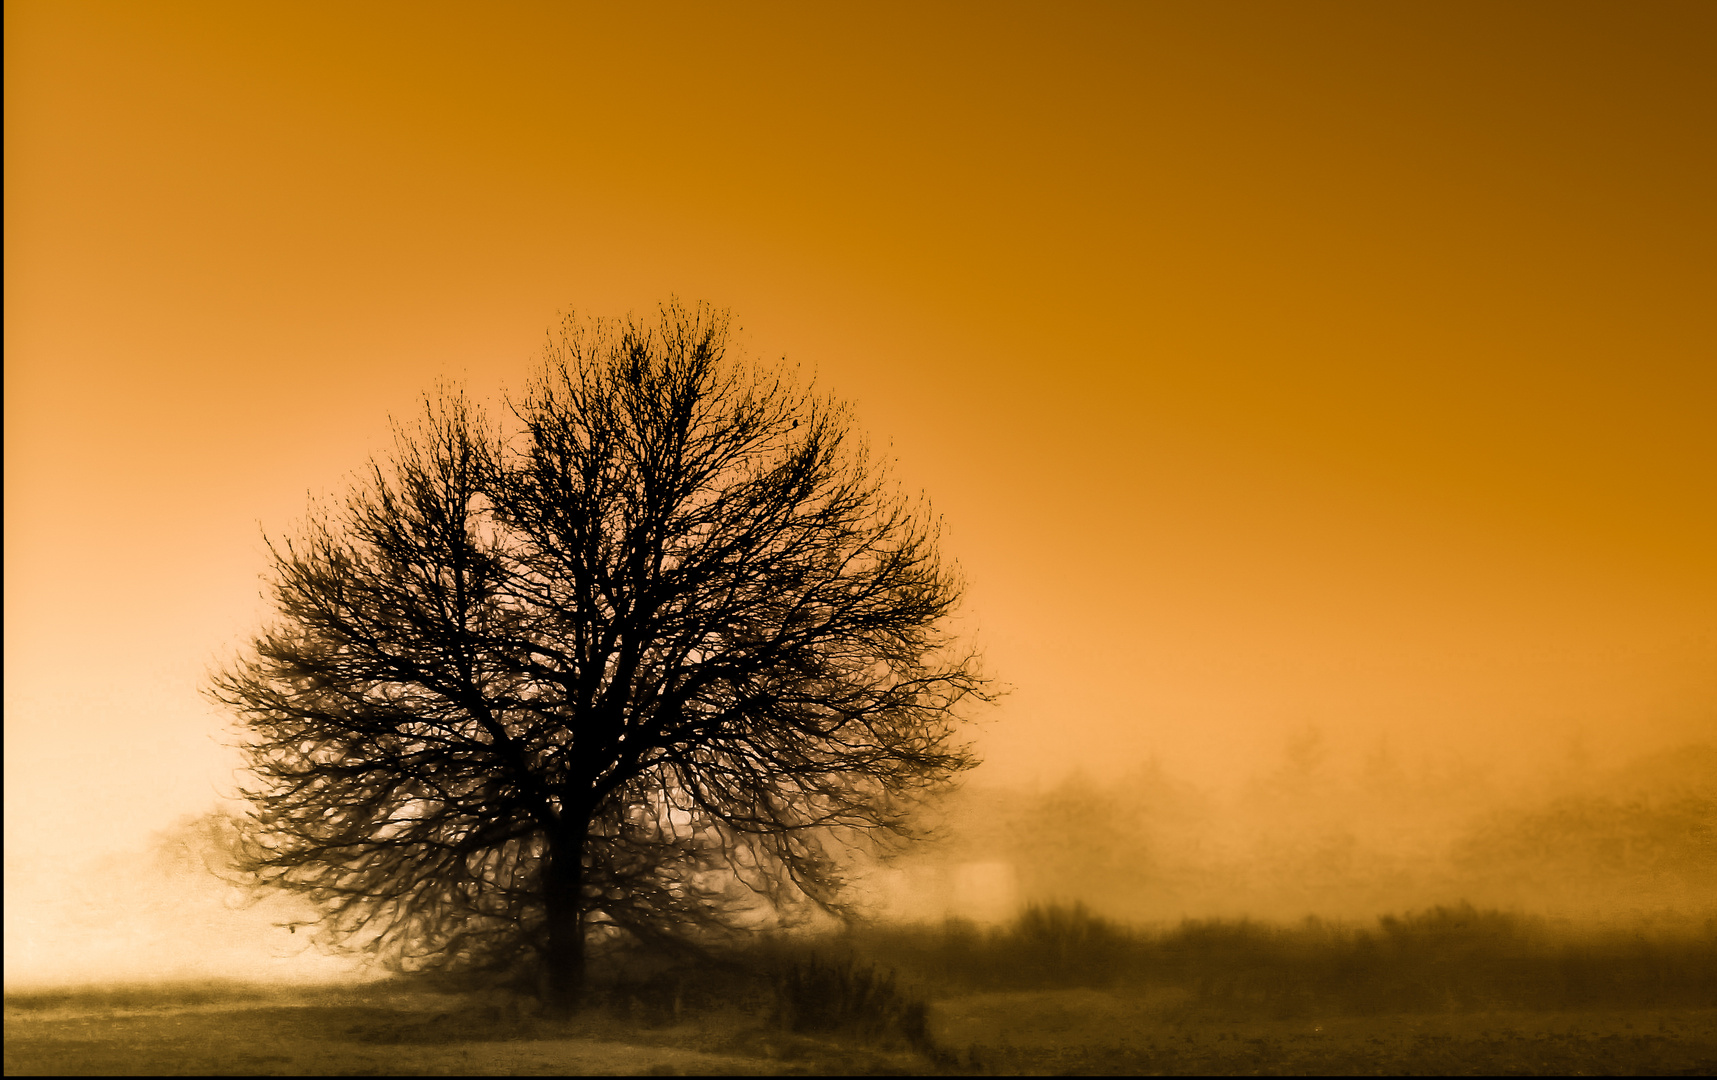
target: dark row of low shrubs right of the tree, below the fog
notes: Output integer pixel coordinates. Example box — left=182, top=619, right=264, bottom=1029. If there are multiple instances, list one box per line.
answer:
left=865, top=905, right=1717, bottom=1016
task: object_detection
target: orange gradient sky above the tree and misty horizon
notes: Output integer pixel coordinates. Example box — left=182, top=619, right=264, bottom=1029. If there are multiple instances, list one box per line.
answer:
left=5, top=0, right=1717, bottom=857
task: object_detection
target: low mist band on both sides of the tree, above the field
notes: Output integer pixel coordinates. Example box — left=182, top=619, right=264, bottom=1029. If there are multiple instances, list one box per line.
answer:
left=5, top=728, right=1717, bottom=987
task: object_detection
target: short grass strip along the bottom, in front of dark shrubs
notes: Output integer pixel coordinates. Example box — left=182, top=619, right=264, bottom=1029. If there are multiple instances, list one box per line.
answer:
left=5, top=986, right=1717, bottom=1075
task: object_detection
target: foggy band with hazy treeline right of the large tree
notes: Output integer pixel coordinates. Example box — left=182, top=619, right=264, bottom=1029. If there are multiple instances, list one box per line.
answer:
left=877, top=728, right=1717, bottom=924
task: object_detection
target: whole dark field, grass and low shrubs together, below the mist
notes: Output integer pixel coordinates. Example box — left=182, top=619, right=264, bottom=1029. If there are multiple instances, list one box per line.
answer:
left=5, top=908, right=1717, bottom=1075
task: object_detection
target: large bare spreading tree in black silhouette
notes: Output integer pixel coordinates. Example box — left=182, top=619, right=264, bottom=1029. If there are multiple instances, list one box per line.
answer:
left=211, top=298, right=987, bottom=1004
